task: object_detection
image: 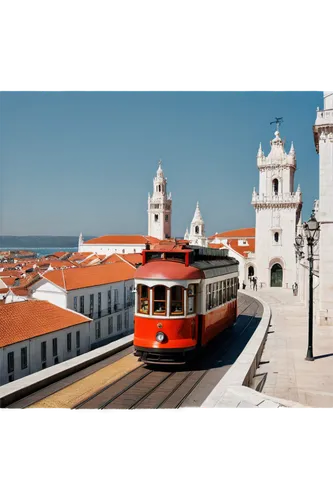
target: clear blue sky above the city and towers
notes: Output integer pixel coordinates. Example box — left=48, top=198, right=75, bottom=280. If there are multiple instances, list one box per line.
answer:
left=0, top=91, right=323, bottom=236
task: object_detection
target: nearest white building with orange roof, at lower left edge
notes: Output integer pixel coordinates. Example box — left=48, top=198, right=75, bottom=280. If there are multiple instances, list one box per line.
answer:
left=0, top=300, right=93, bottom=385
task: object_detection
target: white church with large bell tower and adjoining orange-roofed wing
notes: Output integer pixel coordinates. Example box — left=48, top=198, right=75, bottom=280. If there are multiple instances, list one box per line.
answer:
left=209, top=130, right=302, bottom=288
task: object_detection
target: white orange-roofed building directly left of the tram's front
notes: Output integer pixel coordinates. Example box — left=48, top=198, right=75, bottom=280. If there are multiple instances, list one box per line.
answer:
left=29, top=262, right=136, bottom=348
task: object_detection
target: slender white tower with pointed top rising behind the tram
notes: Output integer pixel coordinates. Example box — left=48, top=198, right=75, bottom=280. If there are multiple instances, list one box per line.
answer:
left=148, top=161, right=172, bottom=240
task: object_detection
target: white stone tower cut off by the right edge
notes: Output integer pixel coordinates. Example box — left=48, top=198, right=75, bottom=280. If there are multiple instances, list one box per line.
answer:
left=313, top=88, right=333, bottom=325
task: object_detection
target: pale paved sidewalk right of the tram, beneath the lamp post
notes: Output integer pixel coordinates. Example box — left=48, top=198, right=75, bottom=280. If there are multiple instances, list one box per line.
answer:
left=246, top=288, right=333, bottom=409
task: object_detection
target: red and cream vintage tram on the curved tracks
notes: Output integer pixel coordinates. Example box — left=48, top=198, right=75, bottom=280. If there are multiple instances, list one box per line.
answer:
left=134, top=242, right=239, bottom=364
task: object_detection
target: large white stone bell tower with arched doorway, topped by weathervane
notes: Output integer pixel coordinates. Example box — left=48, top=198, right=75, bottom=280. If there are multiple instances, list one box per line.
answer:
left=252, top=122, right=302, bottom=288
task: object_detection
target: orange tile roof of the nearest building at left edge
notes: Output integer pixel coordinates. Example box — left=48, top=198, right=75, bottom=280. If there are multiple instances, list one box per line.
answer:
left=0, top=300, right=91, bottom=347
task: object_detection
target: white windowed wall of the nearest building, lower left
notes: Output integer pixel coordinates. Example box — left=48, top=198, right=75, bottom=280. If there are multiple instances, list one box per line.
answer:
left=0, top=320, right=94, bottom=385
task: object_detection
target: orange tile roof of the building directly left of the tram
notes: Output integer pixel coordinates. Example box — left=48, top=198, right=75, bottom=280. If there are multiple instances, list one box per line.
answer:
left=43, top=262, right=136, bottom=290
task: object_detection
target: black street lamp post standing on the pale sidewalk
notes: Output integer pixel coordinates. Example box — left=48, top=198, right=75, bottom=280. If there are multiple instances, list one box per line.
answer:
left=295, top=212, right=319, bottom=361
